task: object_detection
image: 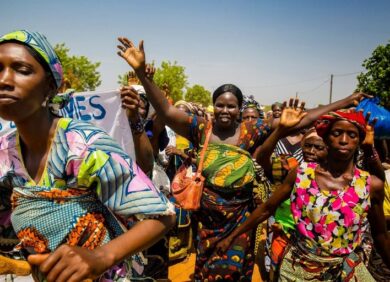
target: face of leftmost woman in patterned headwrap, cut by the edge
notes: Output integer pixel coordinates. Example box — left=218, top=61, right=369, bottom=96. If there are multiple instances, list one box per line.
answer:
left=0, top=43, right=50, bottom=122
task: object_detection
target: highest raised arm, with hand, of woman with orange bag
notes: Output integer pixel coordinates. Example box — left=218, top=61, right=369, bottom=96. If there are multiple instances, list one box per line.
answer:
left=118, top=37, right=190, bottom=138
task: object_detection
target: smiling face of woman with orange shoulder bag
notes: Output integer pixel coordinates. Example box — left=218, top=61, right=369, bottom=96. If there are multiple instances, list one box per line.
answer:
left=214, top=92, right=240, bottom=128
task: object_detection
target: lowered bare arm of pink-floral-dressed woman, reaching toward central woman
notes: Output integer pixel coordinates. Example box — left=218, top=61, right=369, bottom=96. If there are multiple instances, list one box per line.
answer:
left=216, top=166, right=297, bottom=254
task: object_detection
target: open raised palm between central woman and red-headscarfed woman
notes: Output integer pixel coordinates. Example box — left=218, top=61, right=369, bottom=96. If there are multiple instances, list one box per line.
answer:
left=279, top=98, right=307, bottom=128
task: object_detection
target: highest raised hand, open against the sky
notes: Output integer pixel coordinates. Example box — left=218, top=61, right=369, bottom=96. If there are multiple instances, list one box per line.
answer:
left=117, top=37, right=145, bottom=71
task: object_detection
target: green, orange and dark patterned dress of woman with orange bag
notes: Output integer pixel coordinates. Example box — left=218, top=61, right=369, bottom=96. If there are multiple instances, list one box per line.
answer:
left=190, top=117, right=269, bottom=281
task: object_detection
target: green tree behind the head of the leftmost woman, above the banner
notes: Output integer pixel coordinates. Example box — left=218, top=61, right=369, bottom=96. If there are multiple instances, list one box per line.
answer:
left=54, top=43, right=101, bottom=91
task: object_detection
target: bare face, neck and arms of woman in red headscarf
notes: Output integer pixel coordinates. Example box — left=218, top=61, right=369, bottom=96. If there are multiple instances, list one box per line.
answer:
left=217, top=121, right=390, bottom=266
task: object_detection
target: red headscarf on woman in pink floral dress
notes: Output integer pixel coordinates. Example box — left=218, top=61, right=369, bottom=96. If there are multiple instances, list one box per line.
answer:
left=315, top=110, right=366, bottom=142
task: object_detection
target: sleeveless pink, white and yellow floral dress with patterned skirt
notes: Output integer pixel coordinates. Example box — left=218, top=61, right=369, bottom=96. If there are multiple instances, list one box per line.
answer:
left=280, top=163, right=374, bottom=281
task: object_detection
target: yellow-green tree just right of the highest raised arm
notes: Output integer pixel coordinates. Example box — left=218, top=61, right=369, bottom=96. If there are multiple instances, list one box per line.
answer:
left=154, top=61, right=188, bottom=102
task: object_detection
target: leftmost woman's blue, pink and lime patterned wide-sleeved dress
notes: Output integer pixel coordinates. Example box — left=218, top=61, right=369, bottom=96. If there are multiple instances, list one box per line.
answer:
left=0, top=118, right=174, bottom=281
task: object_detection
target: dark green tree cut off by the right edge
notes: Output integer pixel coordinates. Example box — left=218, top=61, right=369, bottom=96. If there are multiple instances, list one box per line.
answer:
left=357, top=42, right=390, bottom=109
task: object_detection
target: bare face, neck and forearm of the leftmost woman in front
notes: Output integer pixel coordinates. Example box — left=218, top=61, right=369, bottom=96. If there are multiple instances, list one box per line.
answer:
left=0, top=43, right=175, bottom=282
